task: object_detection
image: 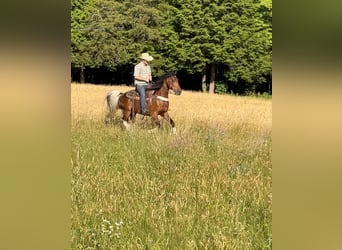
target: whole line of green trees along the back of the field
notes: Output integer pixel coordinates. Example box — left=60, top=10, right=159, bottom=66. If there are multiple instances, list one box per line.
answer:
left=71, top=0, right=272, bottom=94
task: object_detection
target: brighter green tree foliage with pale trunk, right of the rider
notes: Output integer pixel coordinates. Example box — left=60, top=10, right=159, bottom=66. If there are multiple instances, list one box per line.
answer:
left=164, top=0, right=272, bottom=93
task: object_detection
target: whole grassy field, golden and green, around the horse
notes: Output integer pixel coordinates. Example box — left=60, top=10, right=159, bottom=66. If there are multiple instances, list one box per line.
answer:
left=71, top=84, right=272, bottom=249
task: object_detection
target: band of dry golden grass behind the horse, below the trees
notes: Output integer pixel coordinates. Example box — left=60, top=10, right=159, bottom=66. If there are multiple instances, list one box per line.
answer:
left=71, top=84, right=272, bottom=130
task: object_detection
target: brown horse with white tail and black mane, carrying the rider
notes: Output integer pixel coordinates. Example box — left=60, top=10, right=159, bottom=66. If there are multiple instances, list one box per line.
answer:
left=106, top=72, right=182, bottom=132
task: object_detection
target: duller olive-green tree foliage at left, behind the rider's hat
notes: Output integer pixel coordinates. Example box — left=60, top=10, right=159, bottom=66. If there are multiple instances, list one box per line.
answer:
left=71, top=0, right=167, bottom=77
